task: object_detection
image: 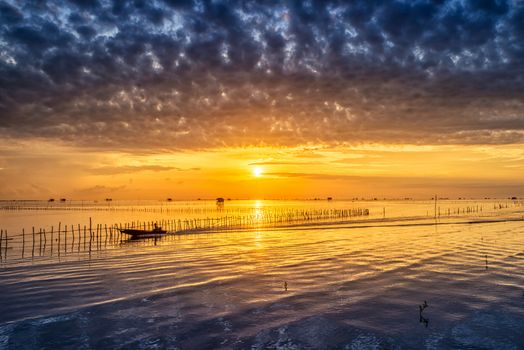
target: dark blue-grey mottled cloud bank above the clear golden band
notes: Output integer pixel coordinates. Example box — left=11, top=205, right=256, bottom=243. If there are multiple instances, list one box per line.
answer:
left=0, top=0, right=524, bottom=149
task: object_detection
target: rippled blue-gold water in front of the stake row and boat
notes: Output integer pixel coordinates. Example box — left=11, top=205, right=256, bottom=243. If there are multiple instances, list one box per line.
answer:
left=0, top=203, right=524, bottom=349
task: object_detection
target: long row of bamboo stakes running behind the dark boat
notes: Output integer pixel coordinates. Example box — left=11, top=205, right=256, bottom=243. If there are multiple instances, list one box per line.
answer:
left=0, top=208, right=369, bottom=259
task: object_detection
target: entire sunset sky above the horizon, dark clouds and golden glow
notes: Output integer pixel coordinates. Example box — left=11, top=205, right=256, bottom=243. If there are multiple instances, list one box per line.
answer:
left=0, top=0, right=524, bottom=199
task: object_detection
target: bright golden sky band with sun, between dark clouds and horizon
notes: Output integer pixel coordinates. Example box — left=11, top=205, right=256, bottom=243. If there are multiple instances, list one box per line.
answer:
left=0, top=141, right=524, bottom=199
